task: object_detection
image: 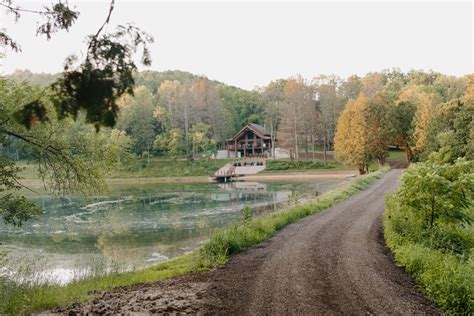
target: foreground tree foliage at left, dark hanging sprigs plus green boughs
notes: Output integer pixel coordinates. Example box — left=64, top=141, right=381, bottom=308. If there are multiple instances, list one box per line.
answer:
left=0, top=0, right=153, bottom=225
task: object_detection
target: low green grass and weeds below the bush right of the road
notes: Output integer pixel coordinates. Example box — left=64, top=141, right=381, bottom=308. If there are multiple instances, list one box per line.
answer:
left=384, top=190, right=474, bottom=315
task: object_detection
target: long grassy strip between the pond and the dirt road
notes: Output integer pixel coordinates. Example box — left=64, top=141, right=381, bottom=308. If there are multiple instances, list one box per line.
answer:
left=0, top=169, right=387, bottom=314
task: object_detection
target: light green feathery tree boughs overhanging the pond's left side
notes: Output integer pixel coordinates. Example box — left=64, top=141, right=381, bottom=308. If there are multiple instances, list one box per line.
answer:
left=0, top=80, right=124, bottom=225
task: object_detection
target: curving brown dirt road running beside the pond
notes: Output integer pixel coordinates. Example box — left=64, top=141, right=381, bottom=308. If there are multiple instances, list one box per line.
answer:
left=57, top=170, right=439, bottom=315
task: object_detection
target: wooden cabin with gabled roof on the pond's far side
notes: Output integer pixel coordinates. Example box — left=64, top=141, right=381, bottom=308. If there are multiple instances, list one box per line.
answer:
left=227, top=123, right=273, bottom=158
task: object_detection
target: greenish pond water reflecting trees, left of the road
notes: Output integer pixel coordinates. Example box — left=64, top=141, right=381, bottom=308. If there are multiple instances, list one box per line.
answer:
left=0, top=180, right=343, bottom=283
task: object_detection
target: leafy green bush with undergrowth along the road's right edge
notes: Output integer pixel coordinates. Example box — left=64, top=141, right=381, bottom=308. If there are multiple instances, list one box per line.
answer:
left=384, top=160, right=474, bottom=315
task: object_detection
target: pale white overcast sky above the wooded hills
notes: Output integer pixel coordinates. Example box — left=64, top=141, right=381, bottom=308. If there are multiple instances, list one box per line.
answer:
left=0, top=0, right=474, bottom=89
